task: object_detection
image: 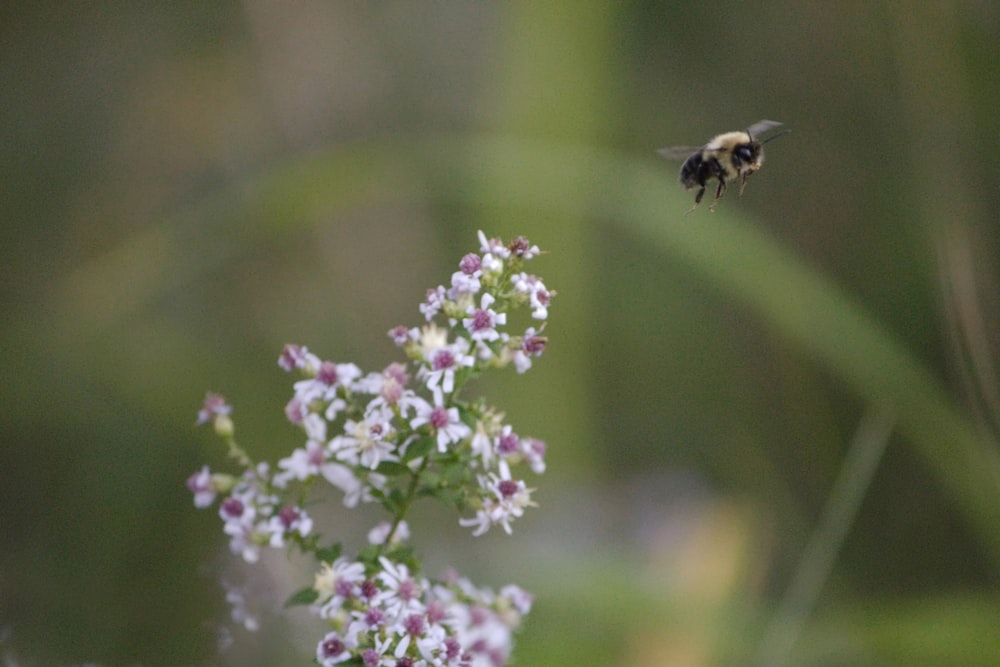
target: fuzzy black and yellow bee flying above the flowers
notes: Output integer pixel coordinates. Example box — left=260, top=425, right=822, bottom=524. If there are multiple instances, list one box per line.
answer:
left=657, top=120, right=791, bottom=213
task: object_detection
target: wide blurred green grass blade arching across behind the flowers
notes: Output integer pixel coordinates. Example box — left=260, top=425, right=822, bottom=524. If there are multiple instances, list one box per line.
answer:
left=43, top=135, right=1000, bottom=567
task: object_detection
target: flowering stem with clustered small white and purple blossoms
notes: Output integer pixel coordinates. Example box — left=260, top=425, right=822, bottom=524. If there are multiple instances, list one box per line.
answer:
left=188, top=232, right=554, bottom=667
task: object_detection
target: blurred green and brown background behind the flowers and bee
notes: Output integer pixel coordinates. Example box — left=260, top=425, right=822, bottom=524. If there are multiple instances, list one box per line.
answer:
left=0, top=0, right=1000, bottom=667
